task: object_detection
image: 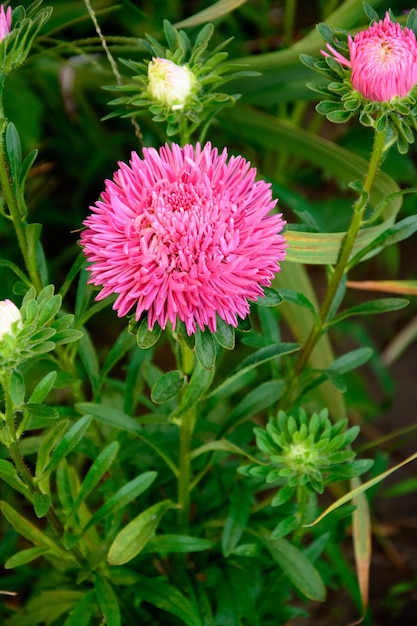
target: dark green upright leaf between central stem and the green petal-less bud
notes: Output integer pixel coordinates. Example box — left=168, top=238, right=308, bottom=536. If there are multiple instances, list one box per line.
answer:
left=222, top=483, right=253, bottom=558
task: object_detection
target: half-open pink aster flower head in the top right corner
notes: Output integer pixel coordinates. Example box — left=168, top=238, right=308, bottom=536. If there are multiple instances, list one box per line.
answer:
left=322, top=12, right=417, bottom=102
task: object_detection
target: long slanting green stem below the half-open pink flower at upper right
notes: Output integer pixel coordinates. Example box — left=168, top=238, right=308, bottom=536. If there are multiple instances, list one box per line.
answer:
left=279, top=131, right=385, bottom=410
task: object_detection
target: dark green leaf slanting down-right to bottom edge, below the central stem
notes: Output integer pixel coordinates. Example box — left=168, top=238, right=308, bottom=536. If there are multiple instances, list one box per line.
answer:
left=136, top=576, right=203, bottom=626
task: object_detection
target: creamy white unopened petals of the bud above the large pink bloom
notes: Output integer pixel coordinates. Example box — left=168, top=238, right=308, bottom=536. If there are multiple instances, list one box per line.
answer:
left=148, top=57, right=196, bottom=111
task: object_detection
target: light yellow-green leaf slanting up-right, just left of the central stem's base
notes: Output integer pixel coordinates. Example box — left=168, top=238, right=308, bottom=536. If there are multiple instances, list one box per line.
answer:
left=107, top=500, right=175, bottom=565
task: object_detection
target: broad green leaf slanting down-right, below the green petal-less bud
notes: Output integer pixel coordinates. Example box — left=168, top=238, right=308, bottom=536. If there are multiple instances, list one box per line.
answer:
left=257, top=529, right=326, bottom=602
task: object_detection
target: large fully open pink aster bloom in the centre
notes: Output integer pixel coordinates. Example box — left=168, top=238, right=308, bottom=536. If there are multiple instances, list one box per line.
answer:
left=81, top=143, right=286, bottom=334
